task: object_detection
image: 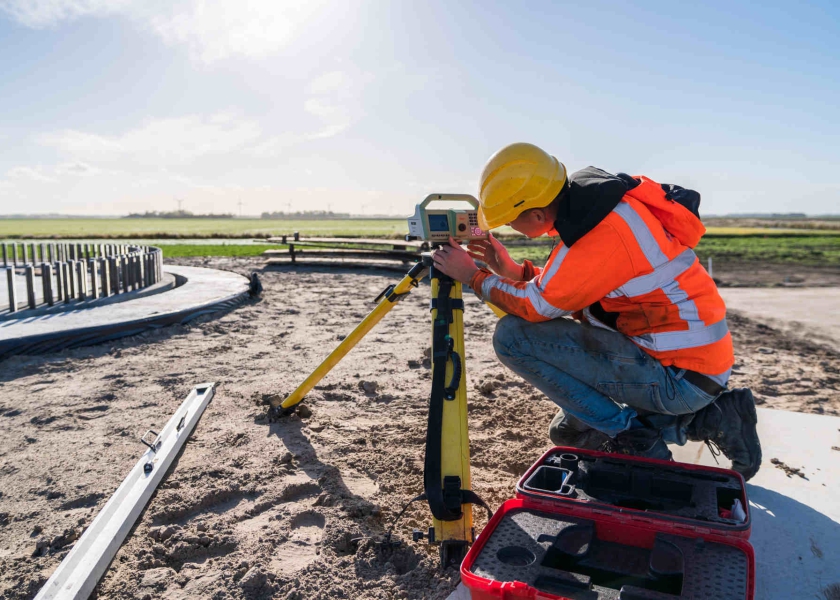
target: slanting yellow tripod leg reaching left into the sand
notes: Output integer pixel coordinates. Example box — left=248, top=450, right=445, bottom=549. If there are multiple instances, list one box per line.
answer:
left=280, top=263, right=429, bottom=409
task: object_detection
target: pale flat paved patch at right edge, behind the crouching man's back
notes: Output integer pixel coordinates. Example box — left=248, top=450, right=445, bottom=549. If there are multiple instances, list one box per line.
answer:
left=719, top=288, right=840, bottom=351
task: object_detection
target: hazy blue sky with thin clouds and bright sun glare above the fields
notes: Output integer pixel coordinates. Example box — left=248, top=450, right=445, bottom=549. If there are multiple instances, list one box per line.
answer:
left=0, top=0, right=840, bottom=216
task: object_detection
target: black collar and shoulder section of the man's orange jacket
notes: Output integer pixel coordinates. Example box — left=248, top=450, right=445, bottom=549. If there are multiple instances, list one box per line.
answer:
left=554, top=167, right=639, bottom=247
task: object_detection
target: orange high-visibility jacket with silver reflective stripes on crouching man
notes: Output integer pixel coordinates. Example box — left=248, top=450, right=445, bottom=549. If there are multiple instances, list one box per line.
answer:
left=470, top=171, right=734, bottom=385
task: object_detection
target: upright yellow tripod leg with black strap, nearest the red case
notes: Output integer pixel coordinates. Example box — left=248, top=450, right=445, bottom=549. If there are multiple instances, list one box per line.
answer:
left=431, top=276, right=473, bottom=565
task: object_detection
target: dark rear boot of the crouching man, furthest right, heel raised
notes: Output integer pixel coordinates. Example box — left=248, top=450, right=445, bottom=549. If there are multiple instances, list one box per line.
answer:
left=686, top=388, right=761, bottom=481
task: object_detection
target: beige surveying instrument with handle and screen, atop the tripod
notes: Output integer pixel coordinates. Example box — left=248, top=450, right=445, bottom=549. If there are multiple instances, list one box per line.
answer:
left=405, top=194, right=487, bottom=247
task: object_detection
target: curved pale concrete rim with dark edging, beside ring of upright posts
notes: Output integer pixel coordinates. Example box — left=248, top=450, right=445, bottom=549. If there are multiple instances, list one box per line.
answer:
left=0, top=266, right=249, bottom=359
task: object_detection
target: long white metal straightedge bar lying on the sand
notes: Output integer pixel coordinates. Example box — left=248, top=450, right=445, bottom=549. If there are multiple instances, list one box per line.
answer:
left=35, top=383, right=216, bottom=600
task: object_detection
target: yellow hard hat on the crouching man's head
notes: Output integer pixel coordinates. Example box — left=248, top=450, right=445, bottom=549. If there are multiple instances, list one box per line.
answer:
left=478, top=142, right=566, bottom=231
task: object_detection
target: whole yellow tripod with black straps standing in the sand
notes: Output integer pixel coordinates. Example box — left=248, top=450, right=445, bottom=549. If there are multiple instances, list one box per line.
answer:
left=281, top=252, right=490, bottom=567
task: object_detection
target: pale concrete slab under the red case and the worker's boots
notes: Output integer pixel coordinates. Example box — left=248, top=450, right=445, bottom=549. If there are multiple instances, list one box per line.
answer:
left=448, top=409, right=840, bottom=600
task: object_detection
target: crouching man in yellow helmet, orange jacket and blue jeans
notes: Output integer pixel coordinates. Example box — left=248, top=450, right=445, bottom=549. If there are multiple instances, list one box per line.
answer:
left=434, top=143, right=761, bottom=479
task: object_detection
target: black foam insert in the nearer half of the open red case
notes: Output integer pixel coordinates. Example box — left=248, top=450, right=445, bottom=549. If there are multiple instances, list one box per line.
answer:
left=471, top=509, right=748, bottom=600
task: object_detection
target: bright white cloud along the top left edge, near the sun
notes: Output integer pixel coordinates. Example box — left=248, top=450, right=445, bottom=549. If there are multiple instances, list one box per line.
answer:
left=0, top=0, right=334, bottom=64
